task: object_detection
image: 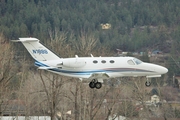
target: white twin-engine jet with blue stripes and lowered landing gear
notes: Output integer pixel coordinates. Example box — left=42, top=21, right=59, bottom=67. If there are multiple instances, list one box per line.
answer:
left=12, top=38, right=168, bottom=89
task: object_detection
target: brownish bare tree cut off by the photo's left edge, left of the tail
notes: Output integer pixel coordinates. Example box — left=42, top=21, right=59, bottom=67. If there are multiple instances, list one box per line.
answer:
left=0, top=34, right=14, bottom=115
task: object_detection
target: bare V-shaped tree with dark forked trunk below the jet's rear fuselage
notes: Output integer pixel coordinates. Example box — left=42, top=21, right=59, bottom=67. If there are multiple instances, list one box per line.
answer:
left=40, top=71, right=65, bottom=120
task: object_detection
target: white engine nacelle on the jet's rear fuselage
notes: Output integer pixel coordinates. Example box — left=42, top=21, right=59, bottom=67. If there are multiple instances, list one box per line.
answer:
left=62, top=59, right=86, bottom=68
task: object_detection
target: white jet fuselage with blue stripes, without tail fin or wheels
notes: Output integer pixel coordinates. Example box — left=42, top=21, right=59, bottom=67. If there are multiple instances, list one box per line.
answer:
left=35, top=57, right=168, bottom=78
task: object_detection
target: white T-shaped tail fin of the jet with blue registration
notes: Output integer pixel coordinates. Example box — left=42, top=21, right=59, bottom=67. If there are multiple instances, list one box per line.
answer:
left=12, top=38, right=60, bottom=61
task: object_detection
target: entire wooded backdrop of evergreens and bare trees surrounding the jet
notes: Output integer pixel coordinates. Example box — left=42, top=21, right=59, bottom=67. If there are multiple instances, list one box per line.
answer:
left=0, top=0, right=180, bottom=120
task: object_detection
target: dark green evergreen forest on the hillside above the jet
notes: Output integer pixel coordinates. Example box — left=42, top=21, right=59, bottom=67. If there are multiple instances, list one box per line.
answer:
left=0, top=0, right=180, bottom=51
